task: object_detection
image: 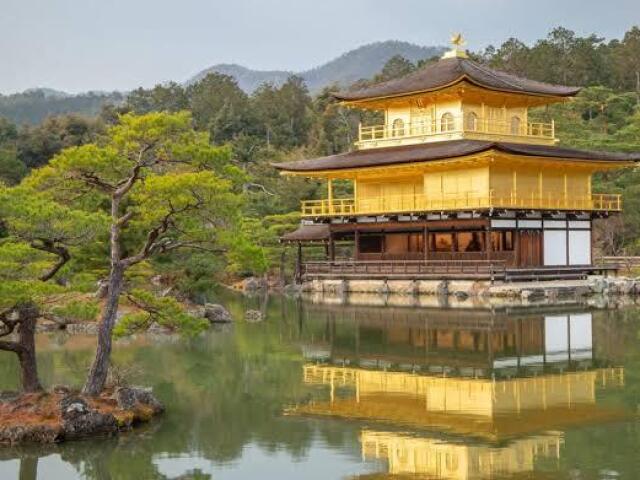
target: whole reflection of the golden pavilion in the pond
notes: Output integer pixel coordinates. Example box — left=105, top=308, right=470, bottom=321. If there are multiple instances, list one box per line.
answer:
left=295, top=308, right=625, bottom=479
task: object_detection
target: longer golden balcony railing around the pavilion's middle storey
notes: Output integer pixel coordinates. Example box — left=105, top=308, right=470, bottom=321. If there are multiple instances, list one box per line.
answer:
left=302, top=191, right=622, bottom=217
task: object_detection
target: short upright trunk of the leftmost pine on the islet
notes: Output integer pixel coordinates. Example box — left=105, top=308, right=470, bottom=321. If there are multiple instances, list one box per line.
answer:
left=17, top=303, right=42, bottom=392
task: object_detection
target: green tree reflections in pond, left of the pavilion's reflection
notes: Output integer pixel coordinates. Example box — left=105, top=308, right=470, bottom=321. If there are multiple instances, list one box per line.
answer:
left=0, top=297, right=359, bottom=480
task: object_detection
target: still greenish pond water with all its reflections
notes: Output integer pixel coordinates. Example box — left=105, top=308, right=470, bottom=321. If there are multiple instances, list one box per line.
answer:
left=0, top=290, right=640, bottom=480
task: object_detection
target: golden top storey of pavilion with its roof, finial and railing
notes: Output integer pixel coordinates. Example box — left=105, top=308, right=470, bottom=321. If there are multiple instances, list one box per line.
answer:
left=334, top=38, right=580, bottom=149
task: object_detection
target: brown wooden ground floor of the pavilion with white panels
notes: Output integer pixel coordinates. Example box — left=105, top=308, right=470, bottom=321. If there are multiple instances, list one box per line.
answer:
left=282, top=212, right=611, bottom=280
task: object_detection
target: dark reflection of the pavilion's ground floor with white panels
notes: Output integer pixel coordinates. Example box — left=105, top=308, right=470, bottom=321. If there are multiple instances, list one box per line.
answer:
left=304, top=306, right=623, bottom=377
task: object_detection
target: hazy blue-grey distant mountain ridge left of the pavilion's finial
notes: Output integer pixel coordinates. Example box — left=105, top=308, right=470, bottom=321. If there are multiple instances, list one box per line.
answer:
left=186, top=40, right=446, bottom=93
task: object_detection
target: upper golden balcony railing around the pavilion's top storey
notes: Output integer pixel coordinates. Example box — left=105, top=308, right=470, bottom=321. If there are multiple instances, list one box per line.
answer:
left=358, top=116, right=555, bottom=144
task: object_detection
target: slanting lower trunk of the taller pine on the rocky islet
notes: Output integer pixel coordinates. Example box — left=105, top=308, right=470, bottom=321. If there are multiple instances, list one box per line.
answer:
left=82, top=264, right=124, bottom=397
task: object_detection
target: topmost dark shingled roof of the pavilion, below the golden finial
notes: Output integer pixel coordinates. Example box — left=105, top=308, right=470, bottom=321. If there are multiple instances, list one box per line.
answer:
left=333, top=57, right=580, bottom=101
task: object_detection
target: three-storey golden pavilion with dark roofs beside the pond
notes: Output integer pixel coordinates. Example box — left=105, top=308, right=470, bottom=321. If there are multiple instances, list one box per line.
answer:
left=274, top=36, right=640, bottom=280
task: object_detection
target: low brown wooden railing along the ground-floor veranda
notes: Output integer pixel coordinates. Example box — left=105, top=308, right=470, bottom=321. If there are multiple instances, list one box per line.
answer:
left=301, top=260, right=506, bottom=280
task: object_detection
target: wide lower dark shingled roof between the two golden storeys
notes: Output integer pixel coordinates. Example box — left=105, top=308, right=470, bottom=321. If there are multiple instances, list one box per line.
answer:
left=272, top=140, right=640, bottom=172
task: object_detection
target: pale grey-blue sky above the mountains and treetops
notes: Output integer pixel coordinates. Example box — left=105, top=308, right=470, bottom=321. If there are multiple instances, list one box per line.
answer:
left=0, top=0, right=640, bottom=94
